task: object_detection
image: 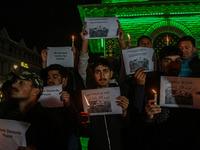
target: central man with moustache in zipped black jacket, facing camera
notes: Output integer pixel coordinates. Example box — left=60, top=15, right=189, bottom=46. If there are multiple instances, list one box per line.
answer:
left=83, top=58, right=129, bottom=150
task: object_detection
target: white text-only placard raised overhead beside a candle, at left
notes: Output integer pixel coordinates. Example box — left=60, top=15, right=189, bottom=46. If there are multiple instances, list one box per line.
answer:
left=47, top=47, right=74, bottom=67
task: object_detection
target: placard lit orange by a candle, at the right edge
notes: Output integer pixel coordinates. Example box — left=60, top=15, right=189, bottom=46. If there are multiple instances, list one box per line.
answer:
left=160, top=76, right=200, bottom=109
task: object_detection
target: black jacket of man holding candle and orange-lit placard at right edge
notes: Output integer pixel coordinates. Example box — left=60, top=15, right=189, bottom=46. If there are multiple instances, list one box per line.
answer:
left=144, top=75, right=200, bottom=150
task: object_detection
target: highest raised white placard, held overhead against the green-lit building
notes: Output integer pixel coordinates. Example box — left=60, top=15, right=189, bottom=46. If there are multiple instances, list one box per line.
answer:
left=85, top=17, right=118, bottom=39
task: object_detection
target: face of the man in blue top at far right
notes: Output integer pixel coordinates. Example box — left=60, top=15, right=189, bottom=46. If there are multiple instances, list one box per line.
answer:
left=179, top=41, right=196, bottom=60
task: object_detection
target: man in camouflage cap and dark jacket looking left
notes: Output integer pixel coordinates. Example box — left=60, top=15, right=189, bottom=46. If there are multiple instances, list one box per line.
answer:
left=0, top=71, right=68, bottom=150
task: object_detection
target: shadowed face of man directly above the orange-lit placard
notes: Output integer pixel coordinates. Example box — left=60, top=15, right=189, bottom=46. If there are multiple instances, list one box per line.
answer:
left=160, top=55, right=181, bottom=76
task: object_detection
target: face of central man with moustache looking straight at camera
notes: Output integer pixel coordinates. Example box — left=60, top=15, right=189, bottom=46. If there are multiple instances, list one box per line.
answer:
left=94, top=65, right=113, bottom=88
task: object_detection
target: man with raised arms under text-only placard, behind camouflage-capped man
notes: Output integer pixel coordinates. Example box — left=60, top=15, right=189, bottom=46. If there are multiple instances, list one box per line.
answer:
left=40, top=47, right=85, bottom=112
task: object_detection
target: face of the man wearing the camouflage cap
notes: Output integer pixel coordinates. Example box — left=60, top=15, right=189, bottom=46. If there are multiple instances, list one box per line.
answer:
left=11, top=79, right=37, bottom=99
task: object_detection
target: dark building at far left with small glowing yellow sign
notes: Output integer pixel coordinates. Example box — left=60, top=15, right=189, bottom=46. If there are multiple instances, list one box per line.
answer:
left=0, top=28, right=42, bottom=95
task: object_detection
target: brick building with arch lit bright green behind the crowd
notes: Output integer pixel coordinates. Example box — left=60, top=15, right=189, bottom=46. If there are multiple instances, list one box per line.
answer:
left=78, top=0, right=200, bottom=56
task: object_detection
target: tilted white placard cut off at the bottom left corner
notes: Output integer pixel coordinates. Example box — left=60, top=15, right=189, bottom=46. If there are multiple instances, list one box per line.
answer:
left=0, top=119, right=30, bottom=150
